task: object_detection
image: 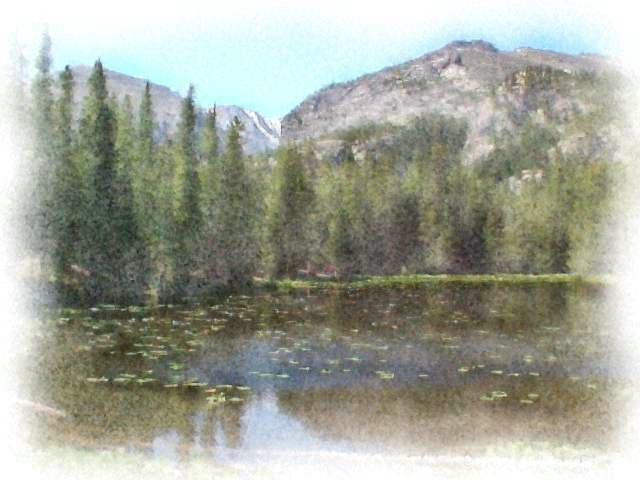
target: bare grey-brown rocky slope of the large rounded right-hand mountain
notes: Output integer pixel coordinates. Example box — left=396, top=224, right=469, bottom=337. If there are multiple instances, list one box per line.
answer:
left=282, top=41, right=614, bottom=162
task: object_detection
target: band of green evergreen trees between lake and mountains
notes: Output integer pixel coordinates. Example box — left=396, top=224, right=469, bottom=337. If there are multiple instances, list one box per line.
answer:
left=5, top=35, right=619, bottom=301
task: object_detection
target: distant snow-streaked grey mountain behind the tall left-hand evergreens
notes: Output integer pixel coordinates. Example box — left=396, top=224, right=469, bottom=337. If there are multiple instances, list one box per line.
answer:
left=73, top=66, right=280, bottom=154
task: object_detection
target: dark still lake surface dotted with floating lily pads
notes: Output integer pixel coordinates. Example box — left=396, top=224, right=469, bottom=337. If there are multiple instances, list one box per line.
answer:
left=27, top=284, right=624, bottom=463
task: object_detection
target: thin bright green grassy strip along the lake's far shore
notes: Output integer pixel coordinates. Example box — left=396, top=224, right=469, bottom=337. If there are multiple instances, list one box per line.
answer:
left=258, top=273, right=613, bottom=291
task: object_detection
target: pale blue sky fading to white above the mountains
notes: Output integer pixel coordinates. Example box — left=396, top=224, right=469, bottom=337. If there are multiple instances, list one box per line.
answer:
left=2, top=0, right=632, bottom=117
